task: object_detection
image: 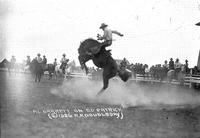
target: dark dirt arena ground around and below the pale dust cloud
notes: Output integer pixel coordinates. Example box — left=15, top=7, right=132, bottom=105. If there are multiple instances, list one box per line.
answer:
left=0, top=72, right=200, bottom=138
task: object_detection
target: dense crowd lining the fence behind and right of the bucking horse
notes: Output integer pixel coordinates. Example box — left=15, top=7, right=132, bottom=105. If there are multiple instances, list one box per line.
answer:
left=90, top=58, right=200, bottom=80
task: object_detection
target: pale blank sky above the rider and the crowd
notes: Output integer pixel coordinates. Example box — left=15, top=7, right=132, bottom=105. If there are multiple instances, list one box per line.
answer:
left=0, top=0, right=200, bottom=67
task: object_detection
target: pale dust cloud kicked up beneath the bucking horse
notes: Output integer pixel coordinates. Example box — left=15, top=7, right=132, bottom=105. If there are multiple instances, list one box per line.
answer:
left=51, top=79, right=200, bottom=109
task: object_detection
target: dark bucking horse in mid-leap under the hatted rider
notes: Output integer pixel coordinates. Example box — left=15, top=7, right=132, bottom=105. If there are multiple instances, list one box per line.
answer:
left=78, top=38, right=131, bottom=95
